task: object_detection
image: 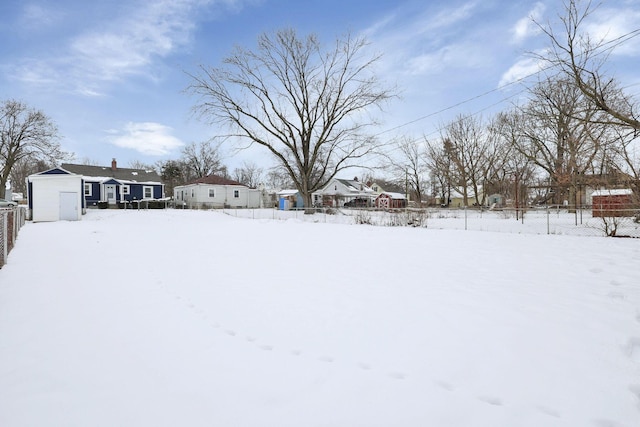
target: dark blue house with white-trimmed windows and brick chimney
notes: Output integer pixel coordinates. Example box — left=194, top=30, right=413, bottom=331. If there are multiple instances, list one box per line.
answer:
left=61, top=159, right=165, bottom=207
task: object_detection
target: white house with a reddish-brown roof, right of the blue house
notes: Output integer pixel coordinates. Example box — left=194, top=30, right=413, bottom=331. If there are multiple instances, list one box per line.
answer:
left=173, top=175, right=261, bottom=209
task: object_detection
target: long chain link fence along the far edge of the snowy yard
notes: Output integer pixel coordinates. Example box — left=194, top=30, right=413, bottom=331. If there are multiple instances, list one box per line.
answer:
left=215, top=206, right=640, bottom=238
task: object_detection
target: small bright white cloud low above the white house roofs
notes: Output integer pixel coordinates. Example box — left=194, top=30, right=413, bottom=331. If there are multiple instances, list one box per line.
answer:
left=107, top=122, right=184, bottom=156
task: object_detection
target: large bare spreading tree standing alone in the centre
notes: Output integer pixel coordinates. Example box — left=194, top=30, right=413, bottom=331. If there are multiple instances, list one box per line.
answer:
left=189, top=29, right=393, bottom=212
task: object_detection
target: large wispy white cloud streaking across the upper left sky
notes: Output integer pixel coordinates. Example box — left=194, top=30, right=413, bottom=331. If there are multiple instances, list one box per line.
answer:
left=11, top=0, right=215, bottom=96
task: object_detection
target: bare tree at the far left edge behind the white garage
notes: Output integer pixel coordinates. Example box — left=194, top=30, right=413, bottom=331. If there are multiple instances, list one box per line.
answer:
left=0, top=100, right=69, bottom=199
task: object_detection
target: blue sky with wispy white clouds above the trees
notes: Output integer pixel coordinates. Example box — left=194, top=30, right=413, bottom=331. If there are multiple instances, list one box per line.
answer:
left=0, top=0, right=640, bottom=168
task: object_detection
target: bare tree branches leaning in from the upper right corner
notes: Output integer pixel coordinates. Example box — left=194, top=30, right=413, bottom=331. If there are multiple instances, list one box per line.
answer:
left=536, top=0, right=640, bottom=132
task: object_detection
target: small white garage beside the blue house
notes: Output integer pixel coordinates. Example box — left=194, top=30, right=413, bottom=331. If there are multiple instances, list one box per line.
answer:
left=27, top=168, right=84, bottom=222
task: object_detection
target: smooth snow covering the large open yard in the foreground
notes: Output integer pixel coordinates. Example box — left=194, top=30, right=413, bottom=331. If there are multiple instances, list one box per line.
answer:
left=0, top=210, right=640, bottom=427
